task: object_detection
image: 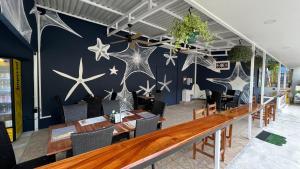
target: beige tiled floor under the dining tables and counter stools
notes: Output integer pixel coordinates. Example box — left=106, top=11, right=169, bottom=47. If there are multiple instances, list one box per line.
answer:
left=14, top=101, right=300, bottom=169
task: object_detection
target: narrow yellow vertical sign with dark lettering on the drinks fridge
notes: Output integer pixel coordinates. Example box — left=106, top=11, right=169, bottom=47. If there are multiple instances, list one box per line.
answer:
left=13, top=59, right=23, bottom=139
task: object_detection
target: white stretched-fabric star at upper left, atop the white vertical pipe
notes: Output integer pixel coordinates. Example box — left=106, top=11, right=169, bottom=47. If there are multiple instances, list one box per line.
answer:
left=30, top=6, right=82, bottom=38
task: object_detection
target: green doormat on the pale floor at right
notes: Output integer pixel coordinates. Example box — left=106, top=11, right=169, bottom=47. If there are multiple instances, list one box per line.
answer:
left=256, top=131, right=286, bottom=146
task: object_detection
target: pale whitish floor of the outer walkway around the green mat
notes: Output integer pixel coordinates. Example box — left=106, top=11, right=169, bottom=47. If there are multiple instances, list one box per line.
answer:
left=227, top=106, right=300, bottom=169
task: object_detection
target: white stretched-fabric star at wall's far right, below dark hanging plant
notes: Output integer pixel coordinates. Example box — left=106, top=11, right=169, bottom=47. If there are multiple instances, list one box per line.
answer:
left=207, top=62, right=250, bottom=102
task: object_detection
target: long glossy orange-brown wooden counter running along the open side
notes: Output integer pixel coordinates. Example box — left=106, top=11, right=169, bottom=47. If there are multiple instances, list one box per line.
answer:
left=40, top=104, right=261, bottom=169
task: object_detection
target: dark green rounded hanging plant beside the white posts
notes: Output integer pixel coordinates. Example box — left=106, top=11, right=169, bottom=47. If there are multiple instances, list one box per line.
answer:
left=228, top=45, right=253, bottom=62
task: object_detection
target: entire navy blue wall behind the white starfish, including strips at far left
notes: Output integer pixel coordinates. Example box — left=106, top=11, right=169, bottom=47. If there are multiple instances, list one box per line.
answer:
left=0, top=1, right=256, bottom=130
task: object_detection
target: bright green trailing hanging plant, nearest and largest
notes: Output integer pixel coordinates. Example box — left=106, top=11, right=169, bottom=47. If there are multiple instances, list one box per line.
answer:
left=170, top=9, right=213, bottom=52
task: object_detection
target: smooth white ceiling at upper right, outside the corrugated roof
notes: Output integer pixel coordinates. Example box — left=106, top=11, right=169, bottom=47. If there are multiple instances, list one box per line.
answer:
left=195, top=0, right=300, bottom=68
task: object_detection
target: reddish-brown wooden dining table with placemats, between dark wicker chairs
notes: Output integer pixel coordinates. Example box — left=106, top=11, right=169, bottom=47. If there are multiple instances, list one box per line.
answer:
left=47, top=110, right=166, bottom=156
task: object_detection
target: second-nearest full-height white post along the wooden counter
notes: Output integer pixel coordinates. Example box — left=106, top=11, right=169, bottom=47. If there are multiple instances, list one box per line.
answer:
left=259, top=51, right=267, bottom=128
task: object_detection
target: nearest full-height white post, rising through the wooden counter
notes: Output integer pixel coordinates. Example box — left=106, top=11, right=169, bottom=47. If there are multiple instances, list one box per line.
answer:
left=248, top=44, right=255, bottom=139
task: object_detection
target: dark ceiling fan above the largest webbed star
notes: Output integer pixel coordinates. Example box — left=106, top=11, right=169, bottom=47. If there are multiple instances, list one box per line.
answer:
left=111, top=24, right=149, bottom=49
